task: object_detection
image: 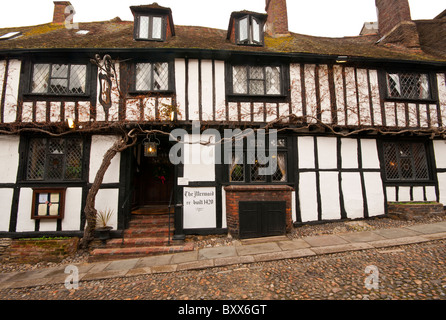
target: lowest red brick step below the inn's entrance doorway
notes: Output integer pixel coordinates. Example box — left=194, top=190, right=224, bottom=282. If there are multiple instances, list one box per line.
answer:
left=89, top=243, right=194, bottom=262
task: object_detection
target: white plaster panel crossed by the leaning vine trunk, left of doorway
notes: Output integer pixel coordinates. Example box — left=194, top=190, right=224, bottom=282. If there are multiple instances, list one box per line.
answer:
left=89, top=135, right=121, bottom=183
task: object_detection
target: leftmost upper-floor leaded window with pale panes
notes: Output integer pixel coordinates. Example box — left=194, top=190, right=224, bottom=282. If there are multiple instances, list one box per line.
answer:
left=31, top=63, right=87, bottom=95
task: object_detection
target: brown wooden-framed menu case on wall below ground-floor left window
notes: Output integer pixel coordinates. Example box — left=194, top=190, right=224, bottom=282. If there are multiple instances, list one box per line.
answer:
left=31, top=188, right=66, bottom=219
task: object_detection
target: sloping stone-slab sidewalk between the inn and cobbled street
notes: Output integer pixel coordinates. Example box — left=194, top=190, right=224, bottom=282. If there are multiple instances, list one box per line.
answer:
left=0, top=221, right=446, bottom=289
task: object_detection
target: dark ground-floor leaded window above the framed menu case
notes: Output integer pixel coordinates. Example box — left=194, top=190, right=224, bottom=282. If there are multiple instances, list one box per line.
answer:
left=26, top=138, right=83, bottom=181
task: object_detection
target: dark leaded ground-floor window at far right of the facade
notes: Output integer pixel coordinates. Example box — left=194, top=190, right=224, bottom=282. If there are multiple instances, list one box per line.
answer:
left=383, top=142, right=430, bottom=180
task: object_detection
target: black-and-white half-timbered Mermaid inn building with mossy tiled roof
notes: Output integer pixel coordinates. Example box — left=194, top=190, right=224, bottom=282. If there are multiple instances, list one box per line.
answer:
left=0, top=0, right=446, bottom=255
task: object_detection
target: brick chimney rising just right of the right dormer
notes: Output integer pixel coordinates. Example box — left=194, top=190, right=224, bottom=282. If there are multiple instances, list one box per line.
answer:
left=265, top=0, right=290, bottom=37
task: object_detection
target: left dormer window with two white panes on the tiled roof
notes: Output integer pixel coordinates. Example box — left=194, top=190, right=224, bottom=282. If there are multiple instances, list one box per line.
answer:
left=130, top=3, right=175, bottom=41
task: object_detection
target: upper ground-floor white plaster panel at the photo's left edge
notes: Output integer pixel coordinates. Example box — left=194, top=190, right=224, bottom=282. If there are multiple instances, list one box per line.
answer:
left=0, top=136, right=20, bottom=183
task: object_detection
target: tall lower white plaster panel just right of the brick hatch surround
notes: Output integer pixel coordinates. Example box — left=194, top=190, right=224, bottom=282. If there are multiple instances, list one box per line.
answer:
left=299, top=172, right=318, bottom=222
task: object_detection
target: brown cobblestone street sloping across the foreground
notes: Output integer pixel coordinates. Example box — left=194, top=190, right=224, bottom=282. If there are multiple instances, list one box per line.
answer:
left=0, top=240, right=446, bottom=300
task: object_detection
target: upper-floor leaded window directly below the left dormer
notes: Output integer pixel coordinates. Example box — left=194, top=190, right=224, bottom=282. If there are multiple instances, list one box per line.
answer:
left=135, top=62, right=169, bottom=91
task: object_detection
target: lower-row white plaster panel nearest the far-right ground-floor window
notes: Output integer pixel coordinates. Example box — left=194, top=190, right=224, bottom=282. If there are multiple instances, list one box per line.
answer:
left=364, top=172, right=385, bottom=217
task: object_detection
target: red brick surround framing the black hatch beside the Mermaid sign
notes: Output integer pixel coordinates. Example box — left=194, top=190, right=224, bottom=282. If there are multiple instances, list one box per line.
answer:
left=225, top=185, right=294, bottom=236
